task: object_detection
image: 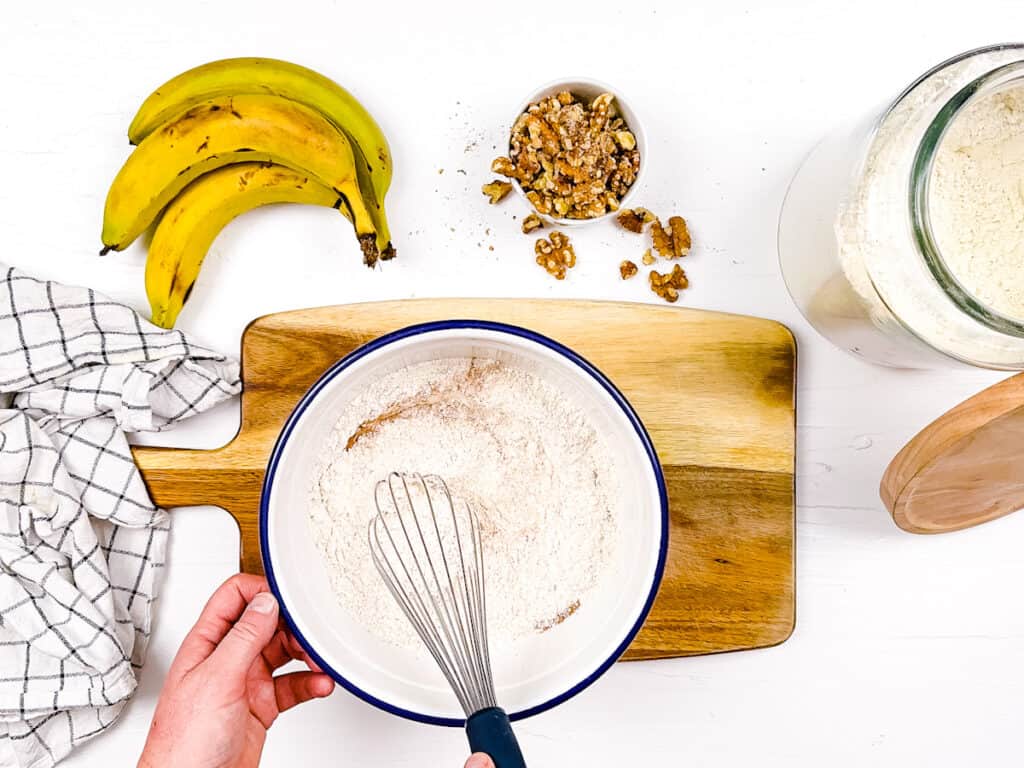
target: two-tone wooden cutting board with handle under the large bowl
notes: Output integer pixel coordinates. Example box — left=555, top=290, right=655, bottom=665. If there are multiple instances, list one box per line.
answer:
left=134, top=299, right=796, bottom=658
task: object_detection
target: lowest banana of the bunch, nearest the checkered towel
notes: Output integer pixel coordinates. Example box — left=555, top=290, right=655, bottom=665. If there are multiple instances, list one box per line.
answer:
left=145, top=163, right=345, bottom=328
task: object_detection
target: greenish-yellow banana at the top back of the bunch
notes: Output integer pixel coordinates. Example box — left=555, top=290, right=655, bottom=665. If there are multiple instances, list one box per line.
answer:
left=128, top=57, right=394, bottom=259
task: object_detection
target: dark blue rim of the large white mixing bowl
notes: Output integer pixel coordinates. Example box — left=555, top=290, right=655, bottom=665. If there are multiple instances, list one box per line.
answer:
left=259, top=319, right=669, bottom=728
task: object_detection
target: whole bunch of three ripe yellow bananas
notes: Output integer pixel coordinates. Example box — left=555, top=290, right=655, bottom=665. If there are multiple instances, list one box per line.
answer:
left=102, top=58, right=394, bottom=328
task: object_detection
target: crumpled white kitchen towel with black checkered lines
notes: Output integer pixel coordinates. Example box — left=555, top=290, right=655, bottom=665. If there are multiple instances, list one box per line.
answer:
left=0, top=264, right=241, bottom=768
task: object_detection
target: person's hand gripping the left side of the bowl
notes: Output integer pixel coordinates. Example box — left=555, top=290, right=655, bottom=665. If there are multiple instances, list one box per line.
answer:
left=138, top=573, right=334, bottom=768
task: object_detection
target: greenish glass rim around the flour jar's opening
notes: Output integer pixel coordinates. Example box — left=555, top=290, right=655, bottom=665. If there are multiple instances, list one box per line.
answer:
left=917, top=44, right=1024, bottom=338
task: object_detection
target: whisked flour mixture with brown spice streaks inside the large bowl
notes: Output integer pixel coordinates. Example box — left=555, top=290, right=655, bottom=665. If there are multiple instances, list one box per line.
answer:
left=309, top=357, right=620, bottom=648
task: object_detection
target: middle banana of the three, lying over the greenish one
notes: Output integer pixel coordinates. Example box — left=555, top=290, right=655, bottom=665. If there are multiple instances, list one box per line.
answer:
left=102, top=94, right=380, bottom=266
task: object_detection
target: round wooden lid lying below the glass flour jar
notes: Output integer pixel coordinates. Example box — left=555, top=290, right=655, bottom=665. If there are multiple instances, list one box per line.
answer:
left=882, top=374, right=1024, bottom=534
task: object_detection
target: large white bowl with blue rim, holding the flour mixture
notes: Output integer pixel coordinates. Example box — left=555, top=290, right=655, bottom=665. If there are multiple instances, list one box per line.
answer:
left=259, top=321, right=669, bottom=726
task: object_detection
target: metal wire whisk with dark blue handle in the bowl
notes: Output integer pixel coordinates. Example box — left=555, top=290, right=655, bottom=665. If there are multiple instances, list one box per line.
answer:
left=369, top=472, right=526, bottom=768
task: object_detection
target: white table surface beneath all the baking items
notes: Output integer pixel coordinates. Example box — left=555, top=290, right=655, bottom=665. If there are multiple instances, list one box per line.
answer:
left=0, top=0, right=1024, bottom=768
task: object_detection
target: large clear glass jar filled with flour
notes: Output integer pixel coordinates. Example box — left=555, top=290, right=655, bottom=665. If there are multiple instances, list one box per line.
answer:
left=778, top=44, right=1024, bottom=370
